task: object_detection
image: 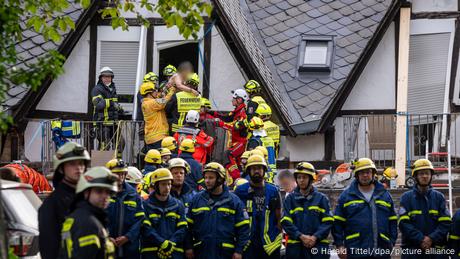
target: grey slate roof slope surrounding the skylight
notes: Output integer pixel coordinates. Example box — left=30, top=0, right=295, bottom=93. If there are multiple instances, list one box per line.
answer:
left=216, top=0, right=398, bottom=134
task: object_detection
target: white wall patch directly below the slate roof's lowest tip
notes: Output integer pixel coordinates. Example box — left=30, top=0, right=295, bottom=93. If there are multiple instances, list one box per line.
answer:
left=286, top=134, right=324, bottom=162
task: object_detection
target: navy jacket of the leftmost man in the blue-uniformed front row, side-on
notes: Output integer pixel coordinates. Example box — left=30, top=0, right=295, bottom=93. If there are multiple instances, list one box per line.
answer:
left=106, top=183, right=145, bottom=259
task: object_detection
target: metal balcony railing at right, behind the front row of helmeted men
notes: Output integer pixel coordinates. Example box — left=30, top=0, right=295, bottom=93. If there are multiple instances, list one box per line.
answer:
left=342, top=114, right=460, bottom=169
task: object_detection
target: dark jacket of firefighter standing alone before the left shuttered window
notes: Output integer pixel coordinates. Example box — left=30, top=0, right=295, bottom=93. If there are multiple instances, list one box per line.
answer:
left=91, top=82, right=118, bottom=125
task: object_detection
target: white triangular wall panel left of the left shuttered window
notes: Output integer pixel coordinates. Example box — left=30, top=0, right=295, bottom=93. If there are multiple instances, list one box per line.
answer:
left=37, top=28, right=89, bottom=113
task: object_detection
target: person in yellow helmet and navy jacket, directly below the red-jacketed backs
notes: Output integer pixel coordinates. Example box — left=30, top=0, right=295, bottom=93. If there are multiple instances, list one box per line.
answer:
left=178, top=139, right=204, bottom=191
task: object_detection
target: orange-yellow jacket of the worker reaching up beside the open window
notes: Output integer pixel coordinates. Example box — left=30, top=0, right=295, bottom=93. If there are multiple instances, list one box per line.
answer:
left=142, top=88, right=174, bottom=144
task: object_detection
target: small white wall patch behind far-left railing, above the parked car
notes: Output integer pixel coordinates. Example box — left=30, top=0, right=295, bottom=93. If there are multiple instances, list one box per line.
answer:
left=24, top=121, right=42, bottom=162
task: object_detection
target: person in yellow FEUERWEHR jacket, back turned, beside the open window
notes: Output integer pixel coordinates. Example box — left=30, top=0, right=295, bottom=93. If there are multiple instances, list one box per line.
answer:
left=166, top=73, right=201, bottom=133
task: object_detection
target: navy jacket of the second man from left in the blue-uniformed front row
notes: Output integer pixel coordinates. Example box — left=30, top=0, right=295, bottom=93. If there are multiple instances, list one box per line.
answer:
left=141, top=193, right=187, bottom=259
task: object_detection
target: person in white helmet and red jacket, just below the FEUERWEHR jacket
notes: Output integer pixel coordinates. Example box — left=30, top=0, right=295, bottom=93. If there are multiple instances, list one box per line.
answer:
left=174, top=110, right=214, bottom=164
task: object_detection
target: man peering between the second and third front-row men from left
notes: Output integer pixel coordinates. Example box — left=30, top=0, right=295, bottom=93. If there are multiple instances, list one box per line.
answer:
left=168, top=158, right=197, bottom=208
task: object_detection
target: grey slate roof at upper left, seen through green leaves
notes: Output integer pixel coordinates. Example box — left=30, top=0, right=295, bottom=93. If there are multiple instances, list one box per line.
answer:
left=1, top=2, right=84, bottom=111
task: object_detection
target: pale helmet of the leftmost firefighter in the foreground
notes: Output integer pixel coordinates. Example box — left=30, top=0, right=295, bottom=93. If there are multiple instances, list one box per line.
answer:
left=53, top=142, right=91, bottom=171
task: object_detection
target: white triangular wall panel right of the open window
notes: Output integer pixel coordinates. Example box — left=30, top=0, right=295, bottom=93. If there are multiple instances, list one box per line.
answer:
left=209, top=27, right=246, bottom=111
